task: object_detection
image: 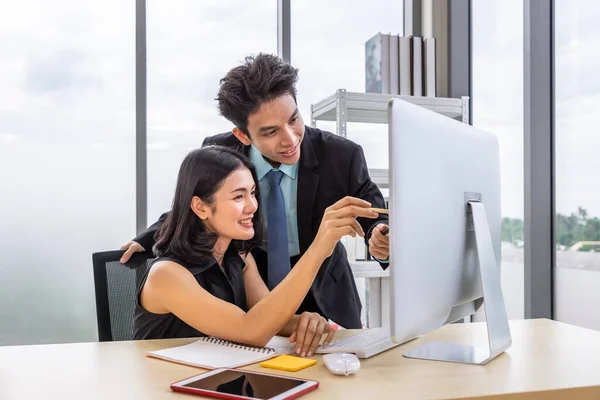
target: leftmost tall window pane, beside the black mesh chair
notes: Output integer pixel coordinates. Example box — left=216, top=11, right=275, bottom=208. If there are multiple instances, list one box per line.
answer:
left=0, top=0, right=135, bottom=345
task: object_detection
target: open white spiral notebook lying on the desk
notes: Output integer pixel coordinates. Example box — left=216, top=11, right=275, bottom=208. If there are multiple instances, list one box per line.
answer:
left=148, top=336, right=295, bottom=369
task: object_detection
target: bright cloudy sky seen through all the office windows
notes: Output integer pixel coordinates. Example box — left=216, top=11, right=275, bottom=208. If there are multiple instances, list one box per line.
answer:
left=0, top=0, right=600, bottom=344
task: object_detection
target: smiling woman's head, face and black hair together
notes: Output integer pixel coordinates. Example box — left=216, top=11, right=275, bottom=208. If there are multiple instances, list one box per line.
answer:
left=154, top=146, right=263, bottom=265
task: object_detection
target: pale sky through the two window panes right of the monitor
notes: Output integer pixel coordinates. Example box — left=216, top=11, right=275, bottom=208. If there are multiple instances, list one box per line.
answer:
left=473, top=0, right=600, bottom=218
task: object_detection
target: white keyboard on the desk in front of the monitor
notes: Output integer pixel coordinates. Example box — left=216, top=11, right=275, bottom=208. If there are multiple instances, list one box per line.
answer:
left=315, top=327, right=400, bottom=358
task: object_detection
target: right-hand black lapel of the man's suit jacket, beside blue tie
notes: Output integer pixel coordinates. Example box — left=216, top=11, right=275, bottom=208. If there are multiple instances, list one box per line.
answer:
left=296, top=128, right=320, bottom=254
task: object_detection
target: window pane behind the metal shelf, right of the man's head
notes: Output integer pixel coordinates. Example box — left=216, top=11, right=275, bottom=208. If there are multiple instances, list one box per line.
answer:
left=291, top=0, right=403, bottom=168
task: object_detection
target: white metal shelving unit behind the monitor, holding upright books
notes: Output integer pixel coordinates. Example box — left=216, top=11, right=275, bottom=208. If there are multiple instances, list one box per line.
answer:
left=310, top=89, right=469, bottom=328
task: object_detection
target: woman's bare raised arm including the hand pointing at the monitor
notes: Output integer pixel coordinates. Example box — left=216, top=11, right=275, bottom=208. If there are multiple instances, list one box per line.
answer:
left=140, top=198, right=377, bottom=346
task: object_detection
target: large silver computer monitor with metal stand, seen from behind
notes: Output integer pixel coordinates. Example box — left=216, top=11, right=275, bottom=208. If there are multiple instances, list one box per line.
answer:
left=388, top=99, right=511, bottom=364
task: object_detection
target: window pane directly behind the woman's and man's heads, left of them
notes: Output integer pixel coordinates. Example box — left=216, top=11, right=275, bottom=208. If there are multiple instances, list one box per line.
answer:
left=147, top=0, right=277, bottom=223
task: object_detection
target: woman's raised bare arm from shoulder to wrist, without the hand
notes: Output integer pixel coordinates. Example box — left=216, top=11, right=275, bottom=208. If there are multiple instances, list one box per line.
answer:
left=140, top=245, right=324, bottom=346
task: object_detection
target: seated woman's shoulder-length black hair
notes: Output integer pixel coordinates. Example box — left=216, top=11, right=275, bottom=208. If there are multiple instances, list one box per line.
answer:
left=153, top=146, right=264, bottom=265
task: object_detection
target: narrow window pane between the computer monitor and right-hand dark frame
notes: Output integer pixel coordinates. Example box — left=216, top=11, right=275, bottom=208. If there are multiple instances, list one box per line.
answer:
left=471, top=0, right=524, bottom=318
